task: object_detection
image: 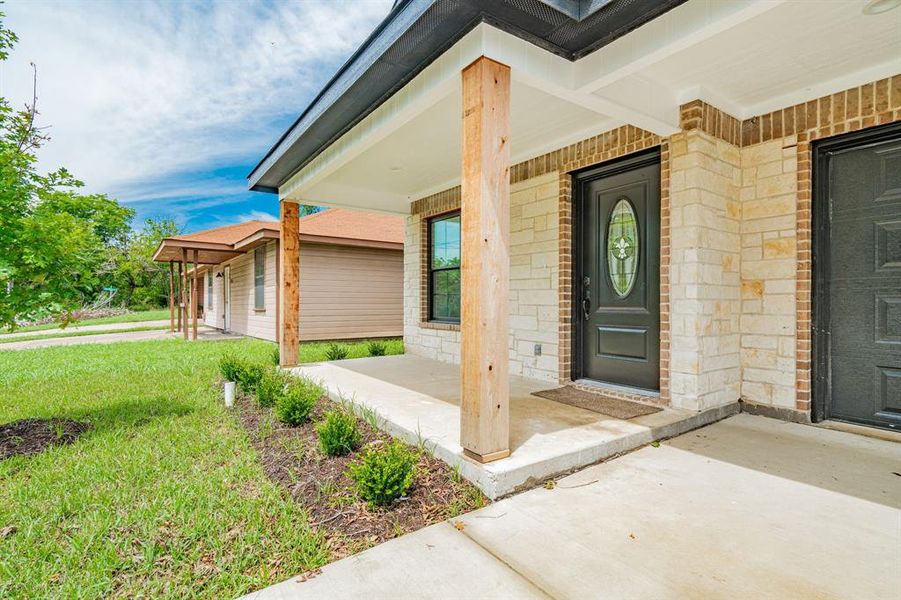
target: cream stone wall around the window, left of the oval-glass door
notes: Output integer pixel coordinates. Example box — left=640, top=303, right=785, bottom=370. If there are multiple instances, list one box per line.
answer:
left=404, top=173, right=560, bottom=382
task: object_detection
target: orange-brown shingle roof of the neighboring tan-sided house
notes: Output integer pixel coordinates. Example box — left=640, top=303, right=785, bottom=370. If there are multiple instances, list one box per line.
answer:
left=153, top=208, right=404, bottom=264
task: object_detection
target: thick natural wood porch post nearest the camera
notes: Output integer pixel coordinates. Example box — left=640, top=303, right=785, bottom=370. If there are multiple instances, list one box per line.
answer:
left=460, top=56, right=510, bottom=462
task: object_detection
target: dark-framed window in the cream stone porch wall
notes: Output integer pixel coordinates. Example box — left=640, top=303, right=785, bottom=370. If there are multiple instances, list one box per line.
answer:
left=429, top=211, right=460, bottom=323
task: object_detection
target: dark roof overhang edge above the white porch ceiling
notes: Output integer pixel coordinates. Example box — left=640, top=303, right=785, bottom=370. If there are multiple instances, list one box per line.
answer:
left=248, top=0, right=686, bottom=192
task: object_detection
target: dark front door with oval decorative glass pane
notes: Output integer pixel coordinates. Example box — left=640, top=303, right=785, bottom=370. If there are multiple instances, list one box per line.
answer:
left=573, top=151, right=660, bottom=390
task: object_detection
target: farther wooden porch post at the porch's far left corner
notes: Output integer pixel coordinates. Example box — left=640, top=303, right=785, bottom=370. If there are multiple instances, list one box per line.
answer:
left=278, top=200, right=300, bottom=367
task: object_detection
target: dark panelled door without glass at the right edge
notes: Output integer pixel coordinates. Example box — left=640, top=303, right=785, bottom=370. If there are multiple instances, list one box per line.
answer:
left=814, top=127, right=901, bottom=429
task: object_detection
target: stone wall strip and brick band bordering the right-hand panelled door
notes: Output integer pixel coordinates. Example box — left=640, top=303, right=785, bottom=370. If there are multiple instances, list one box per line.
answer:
left=682, top=75, right=901, bottom=412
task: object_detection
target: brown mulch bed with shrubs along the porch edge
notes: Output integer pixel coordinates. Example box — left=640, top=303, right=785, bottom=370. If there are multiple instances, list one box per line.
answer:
left=235, top=396, right=488, bottom=559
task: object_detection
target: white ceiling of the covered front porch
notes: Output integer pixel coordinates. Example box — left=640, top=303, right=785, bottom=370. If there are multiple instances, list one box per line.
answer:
left=279, top=0, right=901, bottom=214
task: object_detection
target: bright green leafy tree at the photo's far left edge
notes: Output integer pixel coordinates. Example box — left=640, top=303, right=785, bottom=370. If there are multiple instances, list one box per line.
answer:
left=0, top=13, right=134, bottom=327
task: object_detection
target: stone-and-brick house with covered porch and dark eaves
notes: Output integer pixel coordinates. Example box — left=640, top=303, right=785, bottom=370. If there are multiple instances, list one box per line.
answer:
left=249, top=0, right=901, bottom=461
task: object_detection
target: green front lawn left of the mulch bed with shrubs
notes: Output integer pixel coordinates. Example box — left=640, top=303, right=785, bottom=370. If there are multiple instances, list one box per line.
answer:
left=0, top=340, right=328, bottom=598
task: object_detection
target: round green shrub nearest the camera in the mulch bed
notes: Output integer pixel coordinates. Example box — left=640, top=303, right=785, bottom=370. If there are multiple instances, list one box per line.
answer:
left=348, top=440, right=416, bottom=506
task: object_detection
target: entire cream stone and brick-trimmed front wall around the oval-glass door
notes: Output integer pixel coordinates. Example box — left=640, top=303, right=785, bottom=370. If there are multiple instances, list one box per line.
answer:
left=404, top=75, right=901, bottom=411
